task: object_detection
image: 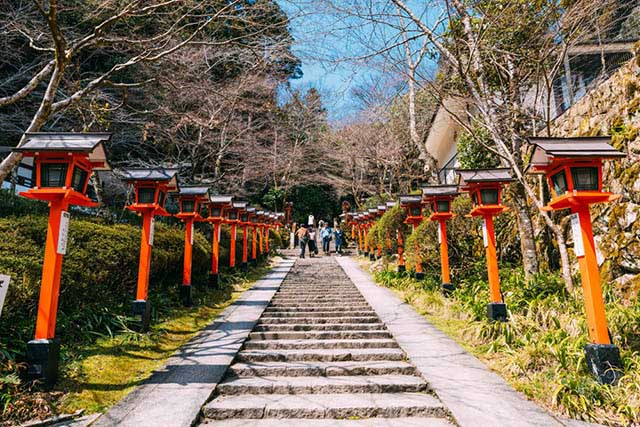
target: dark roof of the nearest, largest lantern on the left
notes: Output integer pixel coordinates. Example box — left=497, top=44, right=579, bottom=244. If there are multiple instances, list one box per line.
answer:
left=12, top=132, right=111, bottom=170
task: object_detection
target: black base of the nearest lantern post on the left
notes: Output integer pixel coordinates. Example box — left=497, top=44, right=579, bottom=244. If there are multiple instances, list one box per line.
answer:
left=27, top=338, right=60, bottom=389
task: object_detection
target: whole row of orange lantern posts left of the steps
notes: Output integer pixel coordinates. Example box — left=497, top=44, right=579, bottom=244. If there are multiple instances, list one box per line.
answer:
left=14, top=133, right=282, bottom=387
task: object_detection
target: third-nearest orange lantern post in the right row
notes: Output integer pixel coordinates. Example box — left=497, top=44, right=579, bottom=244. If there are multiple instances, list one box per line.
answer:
left=422, top=185, right=459, bottom=294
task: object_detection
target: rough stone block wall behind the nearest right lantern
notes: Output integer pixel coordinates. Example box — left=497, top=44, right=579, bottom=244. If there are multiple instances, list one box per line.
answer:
left=553, top=45, right=640, bottom=301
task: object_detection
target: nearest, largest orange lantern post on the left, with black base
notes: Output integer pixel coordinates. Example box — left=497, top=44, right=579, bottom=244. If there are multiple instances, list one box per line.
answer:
left=13, top=133, right=111, bottom=387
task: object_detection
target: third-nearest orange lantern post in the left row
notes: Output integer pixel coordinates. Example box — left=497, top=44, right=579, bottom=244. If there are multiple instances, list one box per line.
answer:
left=175, top=186, right=209, bottom=307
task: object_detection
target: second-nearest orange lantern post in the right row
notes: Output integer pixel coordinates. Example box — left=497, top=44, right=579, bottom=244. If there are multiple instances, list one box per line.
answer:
left=456, top=168, right=513, bottom=322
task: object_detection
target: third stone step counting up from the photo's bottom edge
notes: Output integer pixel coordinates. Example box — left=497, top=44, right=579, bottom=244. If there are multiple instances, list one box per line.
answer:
left=216, top=375, right=427, bottom=395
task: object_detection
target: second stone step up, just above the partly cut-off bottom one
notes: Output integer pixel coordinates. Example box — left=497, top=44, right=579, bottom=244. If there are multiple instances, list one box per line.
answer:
left=203, top=392, right=447, bottom=420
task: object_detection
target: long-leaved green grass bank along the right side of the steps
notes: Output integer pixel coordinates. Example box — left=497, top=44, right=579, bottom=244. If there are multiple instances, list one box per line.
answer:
left=365, top=263, right=640, bottom=426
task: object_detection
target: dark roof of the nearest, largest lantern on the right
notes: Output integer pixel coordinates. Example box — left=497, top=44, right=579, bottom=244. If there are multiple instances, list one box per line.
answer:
left=529, top=136, right=626, bottom=171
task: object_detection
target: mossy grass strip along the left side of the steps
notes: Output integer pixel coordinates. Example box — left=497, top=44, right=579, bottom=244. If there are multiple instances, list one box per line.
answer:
left=0, top=266, right=270, bottom=426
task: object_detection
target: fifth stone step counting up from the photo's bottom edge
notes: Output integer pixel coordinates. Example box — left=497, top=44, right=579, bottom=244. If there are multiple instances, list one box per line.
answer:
left=236, top=348, right=405, bottom=363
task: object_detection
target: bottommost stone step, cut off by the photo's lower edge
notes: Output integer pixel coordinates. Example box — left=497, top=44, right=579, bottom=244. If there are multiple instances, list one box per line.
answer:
left=205, top=416, right=454, bottom=427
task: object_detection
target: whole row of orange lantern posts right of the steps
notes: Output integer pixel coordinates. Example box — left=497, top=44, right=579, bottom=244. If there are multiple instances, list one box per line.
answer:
left=343, top=137, right=625, bottom=384
